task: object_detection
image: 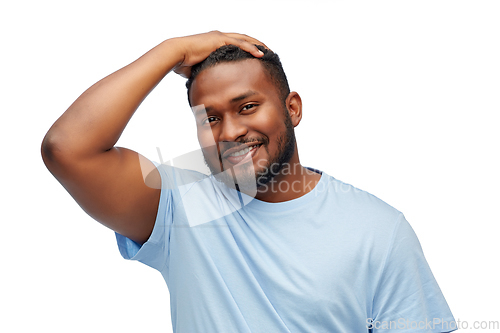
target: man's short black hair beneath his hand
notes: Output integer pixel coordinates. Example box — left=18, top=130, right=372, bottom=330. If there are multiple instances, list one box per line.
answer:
left=186, top=45, right=290, bottom=106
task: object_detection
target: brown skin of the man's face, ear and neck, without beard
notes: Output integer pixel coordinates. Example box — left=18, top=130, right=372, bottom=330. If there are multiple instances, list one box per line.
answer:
left=190, top=59, right=320, bottom=202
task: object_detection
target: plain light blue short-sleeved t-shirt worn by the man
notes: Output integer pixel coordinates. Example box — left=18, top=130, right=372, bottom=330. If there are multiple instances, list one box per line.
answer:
left=116, top=165, right=454, bottom=333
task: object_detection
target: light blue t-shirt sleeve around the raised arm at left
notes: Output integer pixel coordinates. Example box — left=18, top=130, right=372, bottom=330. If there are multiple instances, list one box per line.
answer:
left=115, top=165, right=172, bottom=271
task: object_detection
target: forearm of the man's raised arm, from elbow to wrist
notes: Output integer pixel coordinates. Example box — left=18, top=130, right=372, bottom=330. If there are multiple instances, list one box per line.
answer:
left=43, top=39, right=183, bottom=158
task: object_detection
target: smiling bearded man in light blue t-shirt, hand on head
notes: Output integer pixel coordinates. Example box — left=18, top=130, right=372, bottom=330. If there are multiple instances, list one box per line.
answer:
left=42, top=32, right=454, bottom=333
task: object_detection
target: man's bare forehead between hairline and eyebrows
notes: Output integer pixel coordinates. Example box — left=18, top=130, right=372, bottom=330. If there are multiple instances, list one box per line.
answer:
left=189, top=59, right=278, bottom=106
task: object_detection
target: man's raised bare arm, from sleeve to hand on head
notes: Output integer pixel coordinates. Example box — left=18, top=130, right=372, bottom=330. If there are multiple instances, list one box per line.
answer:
left=42, top=32, right=261, bottom=244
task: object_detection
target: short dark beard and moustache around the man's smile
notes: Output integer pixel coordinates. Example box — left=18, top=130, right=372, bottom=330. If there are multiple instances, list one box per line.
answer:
left=202, top=109, right=295, bottom=195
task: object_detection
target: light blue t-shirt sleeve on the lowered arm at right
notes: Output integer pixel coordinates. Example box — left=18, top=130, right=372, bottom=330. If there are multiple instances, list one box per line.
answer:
left=372, top=214, right=456, bottom=333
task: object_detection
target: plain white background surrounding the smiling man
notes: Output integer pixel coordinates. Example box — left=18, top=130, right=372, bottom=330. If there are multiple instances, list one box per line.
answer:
left=0, top=0, right=500, bottom=333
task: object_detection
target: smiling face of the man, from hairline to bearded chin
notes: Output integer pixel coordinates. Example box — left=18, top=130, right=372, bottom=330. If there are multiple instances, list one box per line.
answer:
left=190, top=59, right=295, bottom=191
